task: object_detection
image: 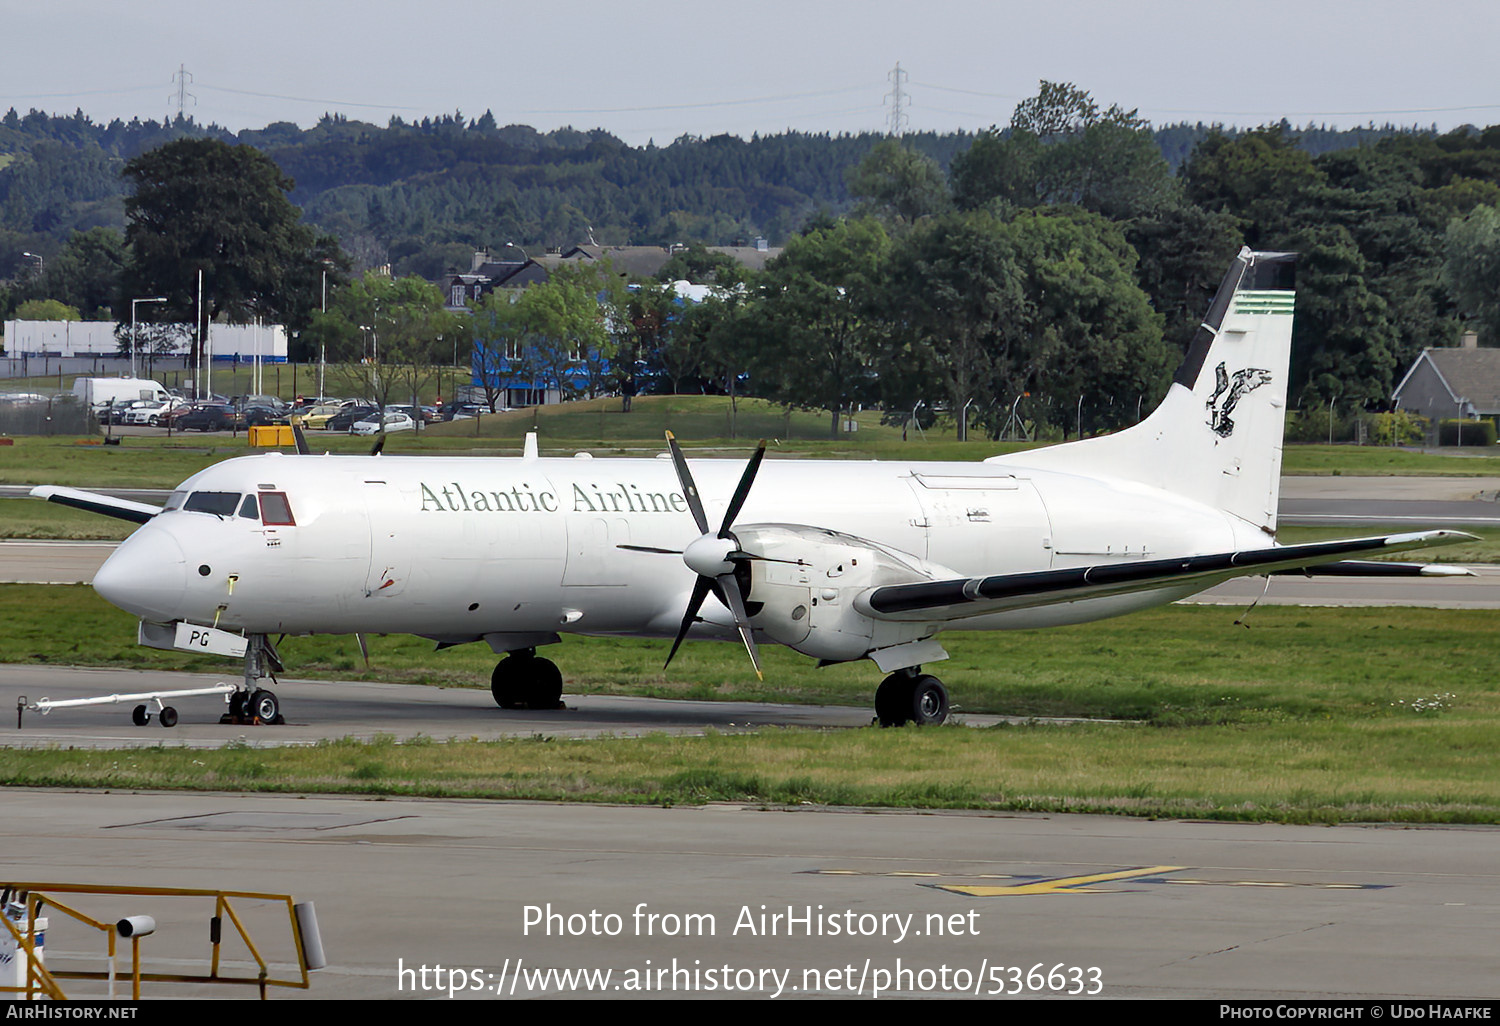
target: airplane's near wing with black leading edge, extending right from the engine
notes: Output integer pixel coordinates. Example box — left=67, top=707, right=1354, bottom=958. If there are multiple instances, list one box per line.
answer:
left=860, top=531, right=1475, bottom=621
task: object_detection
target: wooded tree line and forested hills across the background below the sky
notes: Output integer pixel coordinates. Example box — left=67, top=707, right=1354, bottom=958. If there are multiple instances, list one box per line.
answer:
left=0, top=83, right=1500, bottom=434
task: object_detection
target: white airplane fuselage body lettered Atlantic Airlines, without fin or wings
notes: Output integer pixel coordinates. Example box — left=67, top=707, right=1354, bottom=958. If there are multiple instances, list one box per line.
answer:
left=95, top=453, right=1266, bottom=642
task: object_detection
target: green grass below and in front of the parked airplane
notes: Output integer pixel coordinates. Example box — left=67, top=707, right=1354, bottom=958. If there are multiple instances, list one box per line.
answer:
left=0, top=585, right=1500, bottom=824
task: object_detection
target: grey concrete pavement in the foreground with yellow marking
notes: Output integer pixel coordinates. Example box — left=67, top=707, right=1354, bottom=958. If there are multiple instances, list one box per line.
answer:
left=0, top=791, right=1500, bottom=1002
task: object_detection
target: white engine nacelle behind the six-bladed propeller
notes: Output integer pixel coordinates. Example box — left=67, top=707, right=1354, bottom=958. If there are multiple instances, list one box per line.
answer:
left=735, top=524, right=963, bottom=669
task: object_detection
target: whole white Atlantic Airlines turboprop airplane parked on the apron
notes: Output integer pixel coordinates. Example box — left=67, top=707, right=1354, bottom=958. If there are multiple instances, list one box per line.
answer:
left=33, top=249, right=1469, bottom=725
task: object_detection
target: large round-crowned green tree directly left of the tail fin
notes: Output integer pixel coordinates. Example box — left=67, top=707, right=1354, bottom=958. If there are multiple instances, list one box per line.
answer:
left=885, top=209, right=1173, bottom=431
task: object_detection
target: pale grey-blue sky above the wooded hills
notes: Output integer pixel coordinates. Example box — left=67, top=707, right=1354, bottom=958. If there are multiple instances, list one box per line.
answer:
left=0, top=0, right=1500, bottom=146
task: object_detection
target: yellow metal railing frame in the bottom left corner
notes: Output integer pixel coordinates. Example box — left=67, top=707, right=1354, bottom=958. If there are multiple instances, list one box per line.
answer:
left=0, top=881, right=312, bottom=1001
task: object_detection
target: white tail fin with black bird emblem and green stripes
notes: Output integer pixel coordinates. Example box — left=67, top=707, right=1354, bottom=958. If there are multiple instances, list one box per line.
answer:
left=993, top=249, right=1296, bottom=534
